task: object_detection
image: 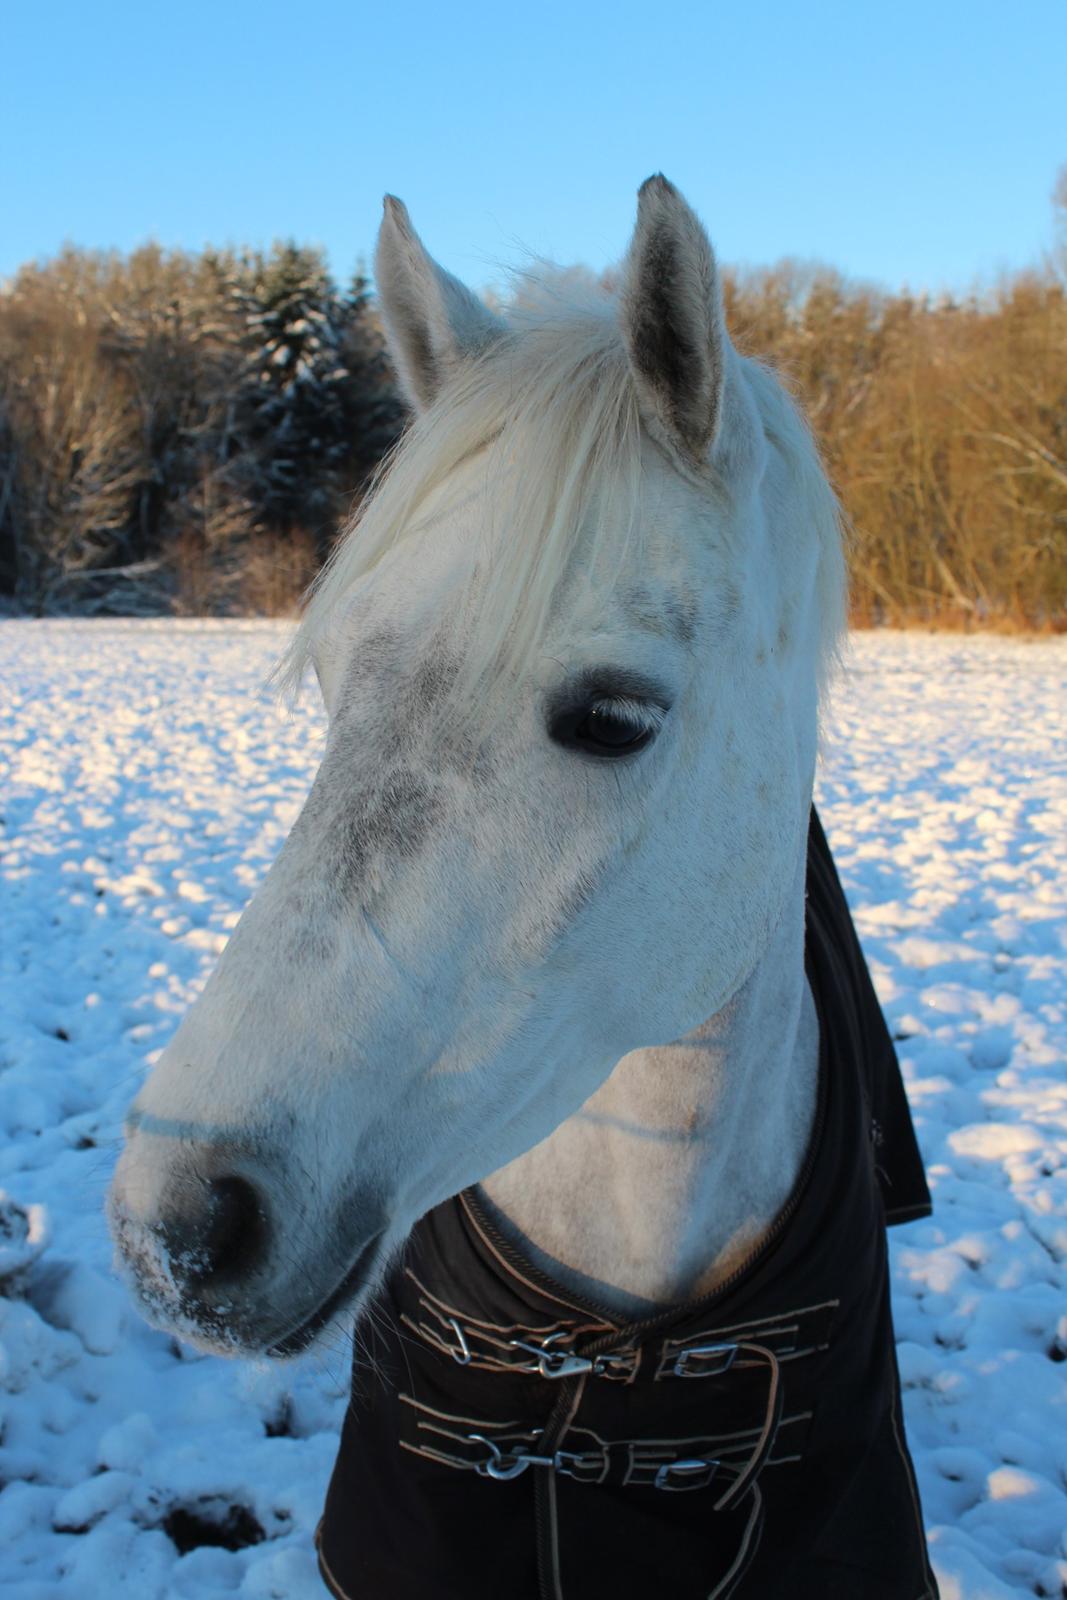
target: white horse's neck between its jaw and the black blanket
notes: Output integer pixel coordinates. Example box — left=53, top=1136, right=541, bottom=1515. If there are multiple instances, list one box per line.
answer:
left=483, top=850, right=819, bottom=1314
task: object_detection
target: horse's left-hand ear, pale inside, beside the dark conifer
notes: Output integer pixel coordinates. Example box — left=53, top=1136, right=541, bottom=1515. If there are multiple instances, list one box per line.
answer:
left=374, top=195, right=504, bottom=411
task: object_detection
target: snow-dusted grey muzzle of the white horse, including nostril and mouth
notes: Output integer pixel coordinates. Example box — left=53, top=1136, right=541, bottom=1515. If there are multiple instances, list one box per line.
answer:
left=107, top=1109, right=384, bottom=1355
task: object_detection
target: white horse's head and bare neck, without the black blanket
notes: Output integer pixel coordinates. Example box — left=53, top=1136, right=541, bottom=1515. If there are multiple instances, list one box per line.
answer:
left=112, top=178, right=845, bottom=1352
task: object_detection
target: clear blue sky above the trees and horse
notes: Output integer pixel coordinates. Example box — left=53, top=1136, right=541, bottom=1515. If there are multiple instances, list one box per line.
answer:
left=0, top=0, right=1067, bottom=290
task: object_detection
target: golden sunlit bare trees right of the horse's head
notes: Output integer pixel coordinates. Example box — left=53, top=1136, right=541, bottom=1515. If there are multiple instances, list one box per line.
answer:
left=726, top=252, right=1067, bottom=629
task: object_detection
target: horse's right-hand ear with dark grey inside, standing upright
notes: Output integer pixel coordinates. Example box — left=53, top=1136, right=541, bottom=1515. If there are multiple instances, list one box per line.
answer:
left=621, top=173, right=728, bottom=462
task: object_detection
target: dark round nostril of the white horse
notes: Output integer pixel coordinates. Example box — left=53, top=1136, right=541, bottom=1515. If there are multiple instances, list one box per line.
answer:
left=160, top=1176, right=267, bottom=1288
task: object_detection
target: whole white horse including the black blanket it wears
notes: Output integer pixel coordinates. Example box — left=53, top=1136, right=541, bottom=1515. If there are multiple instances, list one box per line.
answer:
left=110, top=178, right=936, bottom=1600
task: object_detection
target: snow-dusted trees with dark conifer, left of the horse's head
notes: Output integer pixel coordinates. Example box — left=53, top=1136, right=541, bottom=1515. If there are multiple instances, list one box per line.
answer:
left=0, top=243, right=403, bottom=613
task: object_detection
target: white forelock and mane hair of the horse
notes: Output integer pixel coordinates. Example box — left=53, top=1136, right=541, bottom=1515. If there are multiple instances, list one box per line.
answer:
left=278, top=269, right=845, bottom=714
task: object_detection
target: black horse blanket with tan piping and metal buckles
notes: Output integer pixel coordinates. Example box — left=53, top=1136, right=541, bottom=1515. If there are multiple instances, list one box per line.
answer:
left=317, top=811, right=937, bottom=1600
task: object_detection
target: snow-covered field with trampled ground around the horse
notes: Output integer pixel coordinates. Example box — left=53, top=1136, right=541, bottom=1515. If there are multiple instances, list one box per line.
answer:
left=0, top=621, right=1067, bottom=1600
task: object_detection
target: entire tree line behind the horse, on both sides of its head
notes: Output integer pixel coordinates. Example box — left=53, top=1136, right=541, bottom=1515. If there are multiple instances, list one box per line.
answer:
left=0, top=209, right=1067, bottom=627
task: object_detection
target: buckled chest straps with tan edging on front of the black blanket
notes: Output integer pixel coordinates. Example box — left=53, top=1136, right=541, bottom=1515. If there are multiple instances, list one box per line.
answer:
left=400, top=1267, right=840, bottom=1600
